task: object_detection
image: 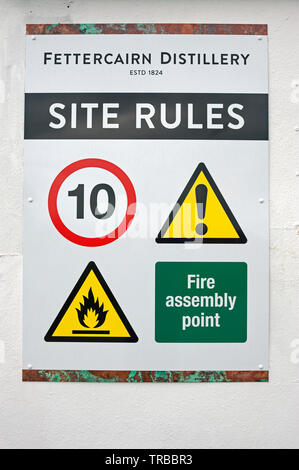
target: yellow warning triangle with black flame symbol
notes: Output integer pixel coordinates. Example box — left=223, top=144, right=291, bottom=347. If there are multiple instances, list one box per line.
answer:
left=45, top=261, right=138, bottom=342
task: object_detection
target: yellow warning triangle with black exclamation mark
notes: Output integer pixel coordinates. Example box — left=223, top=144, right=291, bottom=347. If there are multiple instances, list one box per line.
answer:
left=156, top=163, right=247, bottom=243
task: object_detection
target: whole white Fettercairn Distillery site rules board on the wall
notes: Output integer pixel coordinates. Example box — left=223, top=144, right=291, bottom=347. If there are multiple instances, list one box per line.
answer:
left=23, top=24, right=269, bottom=381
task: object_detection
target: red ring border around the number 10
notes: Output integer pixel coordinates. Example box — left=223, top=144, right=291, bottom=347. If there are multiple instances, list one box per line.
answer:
left=48, top=158, right=136, bottom=247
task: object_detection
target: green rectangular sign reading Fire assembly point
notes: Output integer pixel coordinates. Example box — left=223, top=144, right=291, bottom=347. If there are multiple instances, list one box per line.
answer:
left=155, top=262, right=247, bottom=343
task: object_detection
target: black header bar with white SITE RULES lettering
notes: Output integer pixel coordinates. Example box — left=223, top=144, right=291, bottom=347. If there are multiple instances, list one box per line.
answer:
left=25, top=93, right=268, bottom=140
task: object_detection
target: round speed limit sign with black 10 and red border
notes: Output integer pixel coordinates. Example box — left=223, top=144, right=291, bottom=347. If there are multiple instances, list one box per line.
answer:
left=48, top=158, right=136, bottom=246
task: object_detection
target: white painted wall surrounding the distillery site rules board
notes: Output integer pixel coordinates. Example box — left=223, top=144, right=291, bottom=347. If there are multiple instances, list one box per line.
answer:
left=0, top=0, right=299, bottom=448
